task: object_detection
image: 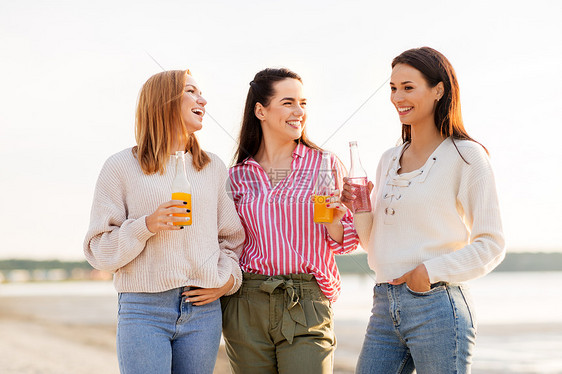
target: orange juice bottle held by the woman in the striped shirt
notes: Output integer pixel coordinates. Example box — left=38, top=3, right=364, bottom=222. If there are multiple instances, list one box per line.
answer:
left=312, top=152, right=336, bottom=223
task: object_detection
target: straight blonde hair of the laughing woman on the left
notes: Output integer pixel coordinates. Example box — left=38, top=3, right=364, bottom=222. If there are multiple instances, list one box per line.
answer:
left=133, top=70, right=211, bottom=175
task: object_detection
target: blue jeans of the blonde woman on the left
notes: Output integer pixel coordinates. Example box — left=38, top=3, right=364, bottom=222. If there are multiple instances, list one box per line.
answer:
left=117, top=288, right=222, bottom=374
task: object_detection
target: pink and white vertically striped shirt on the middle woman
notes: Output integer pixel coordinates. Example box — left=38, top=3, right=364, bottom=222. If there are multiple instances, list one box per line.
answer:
left=230, top=144, right=359, bottom=301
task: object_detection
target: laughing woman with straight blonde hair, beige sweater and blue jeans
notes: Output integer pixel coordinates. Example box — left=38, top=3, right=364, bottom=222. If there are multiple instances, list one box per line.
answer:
left=84, top=70, right=244, bottom=374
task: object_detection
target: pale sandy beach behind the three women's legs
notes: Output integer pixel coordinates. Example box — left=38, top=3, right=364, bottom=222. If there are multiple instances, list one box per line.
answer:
left=0, top=294, right=562, bottom=374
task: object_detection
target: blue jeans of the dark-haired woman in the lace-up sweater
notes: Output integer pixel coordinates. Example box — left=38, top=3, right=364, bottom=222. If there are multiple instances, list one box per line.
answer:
left=356, top=283, right=476, bottom=374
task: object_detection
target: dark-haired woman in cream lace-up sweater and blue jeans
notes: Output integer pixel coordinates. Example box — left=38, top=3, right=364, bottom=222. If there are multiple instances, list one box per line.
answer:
left=342, top=47, right=505, bottom=374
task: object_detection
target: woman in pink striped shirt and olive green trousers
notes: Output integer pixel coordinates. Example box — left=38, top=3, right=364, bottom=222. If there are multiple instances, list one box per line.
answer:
left=222, top=69, right=358, bottom=374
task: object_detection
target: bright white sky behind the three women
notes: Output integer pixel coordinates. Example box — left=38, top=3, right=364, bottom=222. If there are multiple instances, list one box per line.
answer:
left=0, top=0, right=562, bottom=260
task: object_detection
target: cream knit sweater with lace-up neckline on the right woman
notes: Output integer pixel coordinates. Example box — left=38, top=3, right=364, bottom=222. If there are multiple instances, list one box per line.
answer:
left=368, top=138, right=505, bottom=283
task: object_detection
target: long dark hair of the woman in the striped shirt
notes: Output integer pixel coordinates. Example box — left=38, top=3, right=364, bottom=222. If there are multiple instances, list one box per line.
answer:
left=234, top=68, right=320, bottom=164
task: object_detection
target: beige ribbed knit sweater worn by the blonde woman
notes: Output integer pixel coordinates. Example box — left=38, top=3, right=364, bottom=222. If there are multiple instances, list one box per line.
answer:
left=84, top=148, right=244, bottom=294
